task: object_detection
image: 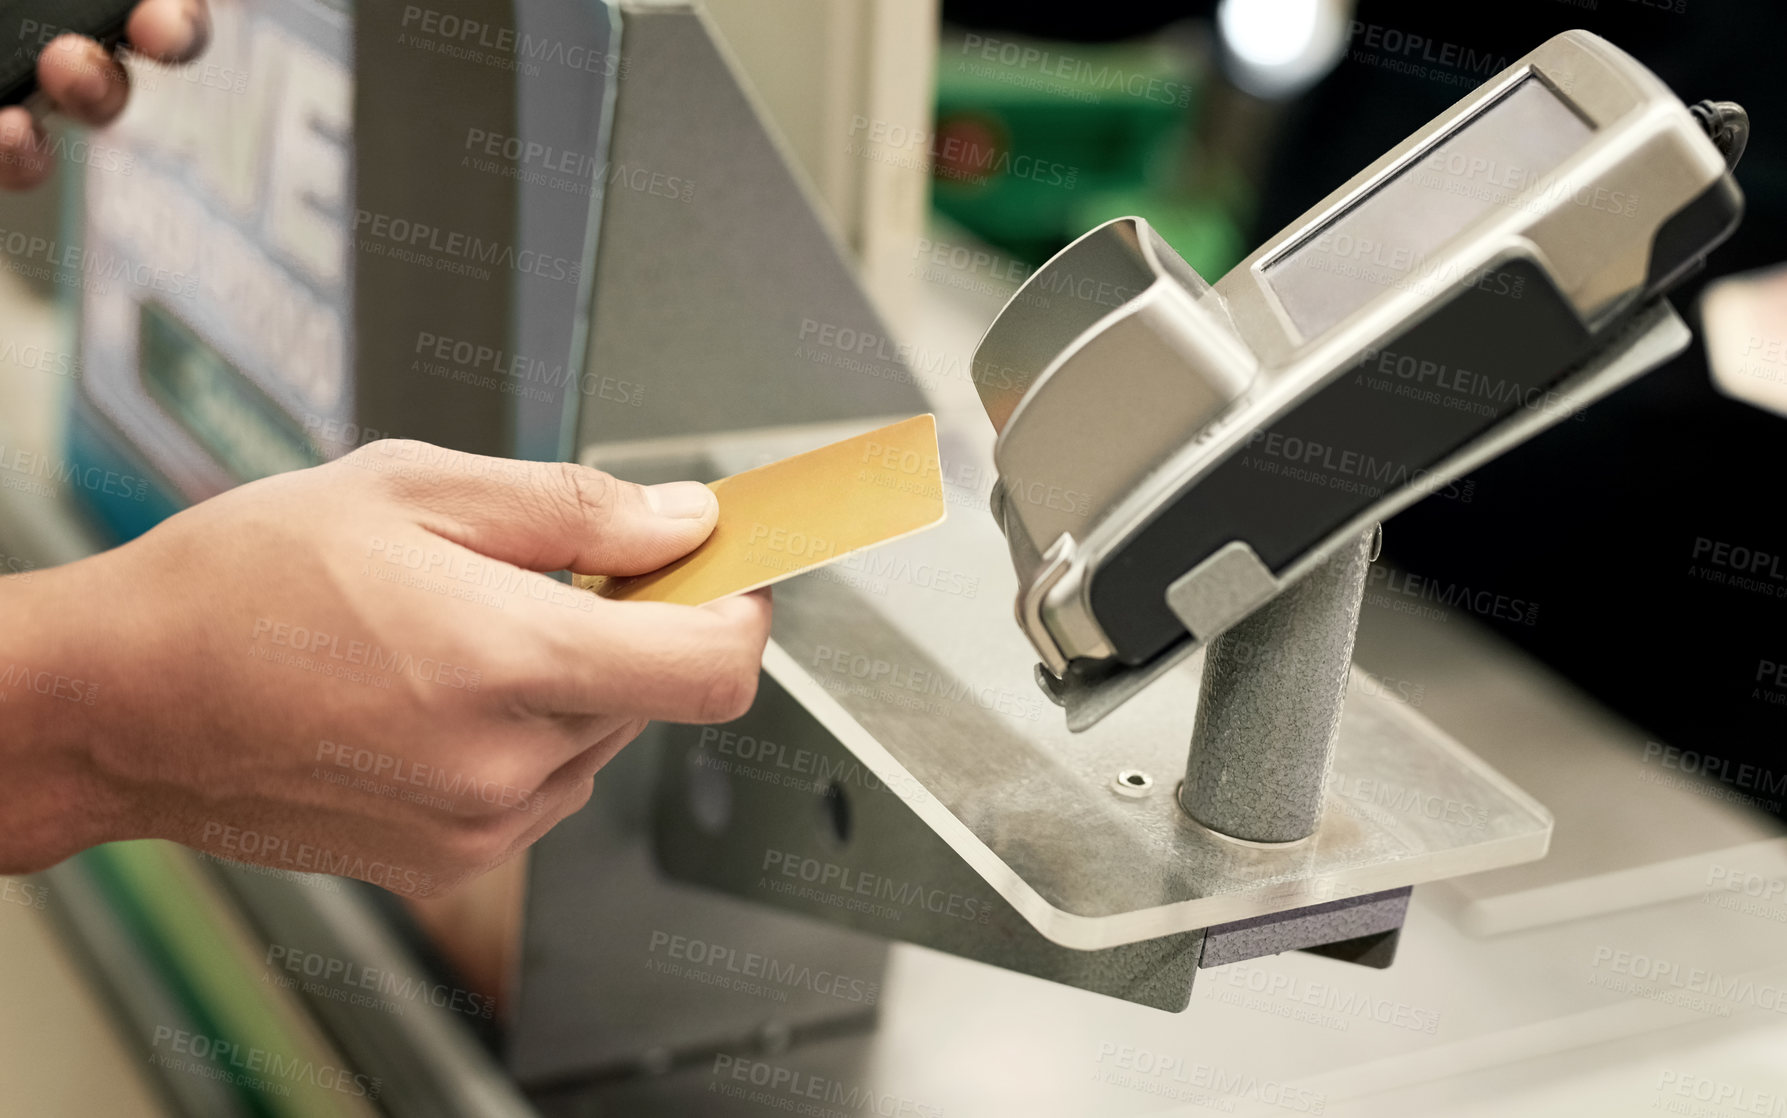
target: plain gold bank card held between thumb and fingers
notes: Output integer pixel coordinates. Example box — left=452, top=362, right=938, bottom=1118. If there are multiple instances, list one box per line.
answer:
left=575, top=414, right=944, bottom=605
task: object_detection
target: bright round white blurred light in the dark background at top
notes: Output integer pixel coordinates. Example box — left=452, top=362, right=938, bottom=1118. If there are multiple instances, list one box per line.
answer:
left=1217, top=0, right=1351, bottom=98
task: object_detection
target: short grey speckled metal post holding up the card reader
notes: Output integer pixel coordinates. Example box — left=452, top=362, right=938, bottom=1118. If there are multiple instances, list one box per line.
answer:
left=1179, top=525, right=1383, bottom=843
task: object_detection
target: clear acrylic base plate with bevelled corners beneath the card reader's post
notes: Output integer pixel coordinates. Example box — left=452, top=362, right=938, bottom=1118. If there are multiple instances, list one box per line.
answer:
left=600, top=414, right=1551, bottom=950
